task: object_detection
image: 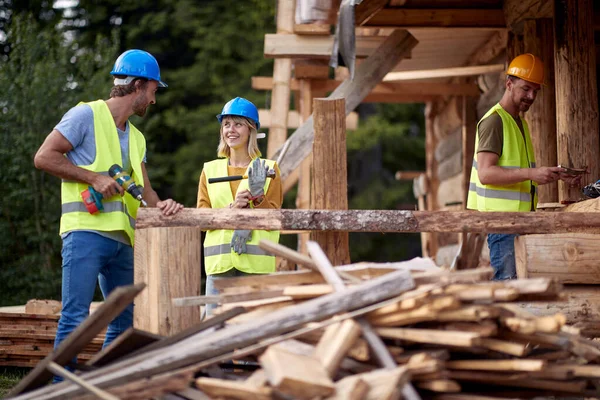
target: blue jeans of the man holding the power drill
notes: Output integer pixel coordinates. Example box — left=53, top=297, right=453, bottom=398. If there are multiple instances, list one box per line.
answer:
left=54, top=231, right=133, bottom=381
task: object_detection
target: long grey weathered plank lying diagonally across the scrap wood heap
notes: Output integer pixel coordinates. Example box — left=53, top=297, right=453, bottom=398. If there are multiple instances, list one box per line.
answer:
left=27, top=271, right=414, bottom=400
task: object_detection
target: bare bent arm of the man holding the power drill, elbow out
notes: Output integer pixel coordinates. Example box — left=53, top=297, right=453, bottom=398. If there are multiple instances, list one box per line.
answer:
left=33, top=129, right=124, bottom=198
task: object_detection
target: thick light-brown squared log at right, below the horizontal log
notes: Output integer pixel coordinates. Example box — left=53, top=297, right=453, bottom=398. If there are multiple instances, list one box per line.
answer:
left=515, top=233, right=600, bottom=284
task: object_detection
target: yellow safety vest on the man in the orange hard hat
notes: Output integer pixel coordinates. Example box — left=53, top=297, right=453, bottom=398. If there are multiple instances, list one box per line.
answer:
left=467, top=103, right=537, bottom=211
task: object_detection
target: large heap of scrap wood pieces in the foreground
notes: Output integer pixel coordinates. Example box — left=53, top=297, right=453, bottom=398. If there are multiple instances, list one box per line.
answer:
left=10, top=243, right=600, bottom=400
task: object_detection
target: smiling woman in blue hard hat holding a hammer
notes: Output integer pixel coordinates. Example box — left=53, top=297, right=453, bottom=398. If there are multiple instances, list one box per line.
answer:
left=197, top=97, right=283, bottom=315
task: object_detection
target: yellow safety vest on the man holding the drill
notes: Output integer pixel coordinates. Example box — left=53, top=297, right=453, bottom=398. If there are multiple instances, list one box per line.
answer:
left=60, top=100, right=146, bottom=246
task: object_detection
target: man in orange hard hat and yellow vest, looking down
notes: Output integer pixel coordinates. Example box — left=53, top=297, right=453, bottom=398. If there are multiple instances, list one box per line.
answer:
left=467, top=53, right=579, bottom=280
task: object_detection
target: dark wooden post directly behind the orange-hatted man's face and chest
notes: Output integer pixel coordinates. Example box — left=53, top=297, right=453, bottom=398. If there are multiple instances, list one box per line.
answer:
left=524, top=18, right=558, bottom=203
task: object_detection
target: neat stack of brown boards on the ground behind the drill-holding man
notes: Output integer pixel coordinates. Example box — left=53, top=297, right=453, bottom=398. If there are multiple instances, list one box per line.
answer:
left=0, top=306, right=104, bottom=367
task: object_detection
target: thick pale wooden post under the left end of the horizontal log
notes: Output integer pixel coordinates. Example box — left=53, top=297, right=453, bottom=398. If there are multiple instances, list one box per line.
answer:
left=133, top=227, right=202, bottom=336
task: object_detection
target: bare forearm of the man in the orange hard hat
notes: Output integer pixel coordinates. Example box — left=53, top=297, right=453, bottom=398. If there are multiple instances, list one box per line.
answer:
left=477, top=151, right=563, bottom=185
